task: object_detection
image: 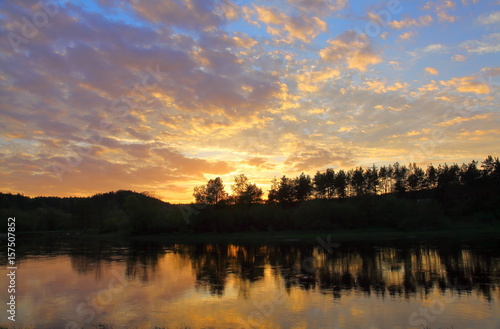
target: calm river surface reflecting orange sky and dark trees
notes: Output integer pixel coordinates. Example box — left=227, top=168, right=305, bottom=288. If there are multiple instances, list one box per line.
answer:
left=0, top=236, right=500, bottom=329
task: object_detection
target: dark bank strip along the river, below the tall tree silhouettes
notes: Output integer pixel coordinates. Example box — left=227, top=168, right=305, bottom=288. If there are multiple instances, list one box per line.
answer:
left=4, top=187, right=500, bottom=233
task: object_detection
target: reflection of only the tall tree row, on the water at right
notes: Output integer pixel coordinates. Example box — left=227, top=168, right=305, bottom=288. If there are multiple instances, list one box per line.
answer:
left=171, top=238, right=500, bottom=300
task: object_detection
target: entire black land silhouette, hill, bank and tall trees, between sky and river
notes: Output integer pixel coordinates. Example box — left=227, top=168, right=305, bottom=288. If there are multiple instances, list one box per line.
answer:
left=0, top=156, right=500, bottom=234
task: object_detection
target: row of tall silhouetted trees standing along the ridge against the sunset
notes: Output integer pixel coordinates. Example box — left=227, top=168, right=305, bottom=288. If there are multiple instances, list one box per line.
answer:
left=193, top=156, right=500, bottom=205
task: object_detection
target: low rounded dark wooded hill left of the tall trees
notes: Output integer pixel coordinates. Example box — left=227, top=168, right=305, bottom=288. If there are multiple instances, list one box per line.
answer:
left=0, top=190, right=184, bottom=234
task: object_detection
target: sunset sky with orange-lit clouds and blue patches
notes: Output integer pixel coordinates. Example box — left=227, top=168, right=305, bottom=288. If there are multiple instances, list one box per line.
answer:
left=0, top=0, right=500, bottom=203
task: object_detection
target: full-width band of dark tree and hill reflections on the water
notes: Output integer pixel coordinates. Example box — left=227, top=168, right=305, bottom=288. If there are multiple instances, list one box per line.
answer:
left=10, top=234, right=500, bottom=301
